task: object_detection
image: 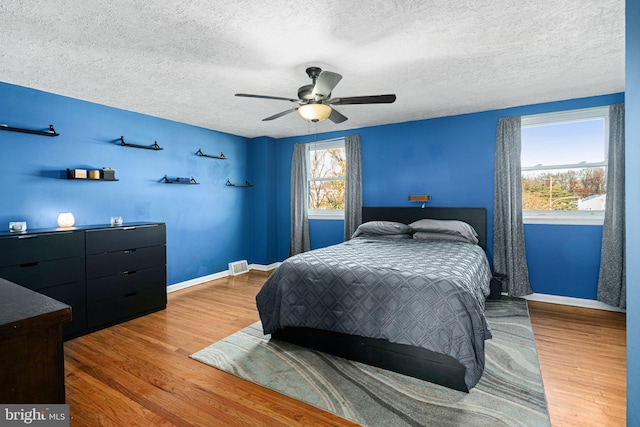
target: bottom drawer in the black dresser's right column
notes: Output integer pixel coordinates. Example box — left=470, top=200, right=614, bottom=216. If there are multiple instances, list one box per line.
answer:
left=87, top=287, right=167, bottom=329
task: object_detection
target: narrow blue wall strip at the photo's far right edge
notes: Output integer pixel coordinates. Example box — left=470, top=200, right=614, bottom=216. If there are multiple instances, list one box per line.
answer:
left=625, top=0, right=640, bottom=427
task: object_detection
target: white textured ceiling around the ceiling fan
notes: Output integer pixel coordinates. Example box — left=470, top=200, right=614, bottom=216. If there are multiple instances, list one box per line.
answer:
left=0, top=0, right=624, bottom=137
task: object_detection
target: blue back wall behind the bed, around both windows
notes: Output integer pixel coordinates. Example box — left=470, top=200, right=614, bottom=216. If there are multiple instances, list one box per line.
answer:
left=276, top=94, right=624, bottom=299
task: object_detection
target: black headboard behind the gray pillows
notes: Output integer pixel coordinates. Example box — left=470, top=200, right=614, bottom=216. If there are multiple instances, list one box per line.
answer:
left=362, top=207, right=487, bottom=251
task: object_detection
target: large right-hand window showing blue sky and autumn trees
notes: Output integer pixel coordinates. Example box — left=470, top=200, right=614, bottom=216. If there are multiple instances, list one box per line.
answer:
left=521, top=106, right=609, bottom=224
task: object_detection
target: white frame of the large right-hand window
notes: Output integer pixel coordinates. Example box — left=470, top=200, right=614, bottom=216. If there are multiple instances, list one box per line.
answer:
left=520, top=105, right=609, bottom=225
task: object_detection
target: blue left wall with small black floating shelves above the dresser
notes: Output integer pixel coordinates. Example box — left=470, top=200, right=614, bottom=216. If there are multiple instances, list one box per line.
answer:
left=0, top=83, right=252, bottom=284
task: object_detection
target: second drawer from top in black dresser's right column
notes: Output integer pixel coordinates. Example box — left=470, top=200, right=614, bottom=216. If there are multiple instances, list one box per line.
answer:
left=87, top=246, right=167, bottom=279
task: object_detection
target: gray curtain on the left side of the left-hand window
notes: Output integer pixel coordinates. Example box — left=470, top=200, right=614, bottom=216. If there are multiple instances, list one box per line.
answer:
left=289, top=144, right=311, bottom=256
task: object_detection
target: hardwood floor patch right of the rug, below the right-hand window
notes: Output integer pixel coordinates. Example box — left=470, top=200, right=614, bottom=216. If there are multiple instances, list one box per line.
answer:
left=529, top=301, right=627, bottom=426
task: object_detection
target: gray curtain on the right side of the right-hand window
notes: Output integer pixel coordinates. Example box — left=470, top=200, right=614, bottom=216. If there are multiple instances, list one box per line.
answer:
left=598, top=104, right=627, bottom=308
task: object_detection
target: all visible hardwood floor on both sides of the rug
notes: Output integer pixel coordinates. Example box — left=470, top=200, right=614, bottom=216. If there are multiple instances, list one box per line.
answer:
left=65, top=272, right=625, bottom=426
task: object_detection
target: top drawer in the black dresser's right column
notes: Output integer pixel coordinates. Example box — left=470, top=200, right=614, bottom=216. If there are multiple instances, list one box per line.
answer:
left=86, top=224, right=166, bottom=254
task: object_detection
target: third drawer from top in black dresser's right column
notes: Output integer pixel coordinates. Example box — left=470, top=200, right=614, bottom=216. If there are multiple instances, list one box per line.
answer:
left=87, top=265, right=167, bottom=303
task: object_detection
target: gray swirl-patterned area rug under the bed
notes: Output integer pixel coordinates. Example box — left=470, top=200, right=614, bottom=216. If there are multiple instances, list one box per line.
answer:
left=191, top=297, right=550, bottom=427
